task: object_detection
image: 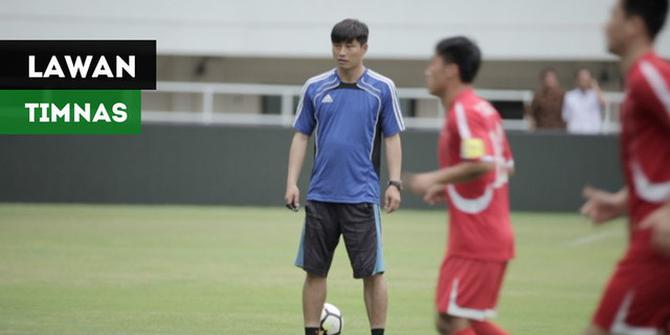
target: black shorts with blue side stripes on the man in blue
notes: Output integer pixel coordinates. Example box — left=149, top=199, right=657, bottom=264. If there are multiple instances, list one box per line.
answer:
left=295, top=201, right=384, bottom=278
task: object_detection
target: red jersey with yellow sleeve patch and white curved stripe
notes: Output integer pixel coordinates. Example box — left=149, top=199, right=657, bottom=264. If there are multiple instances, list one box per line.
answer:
left=438, top=89, right=514, bottom=261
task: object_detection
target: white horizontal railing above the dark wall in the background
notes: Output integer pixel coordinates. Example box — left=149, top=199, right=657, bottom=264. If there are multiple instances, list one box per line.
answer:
left=142, top=81, right=623, bottom=132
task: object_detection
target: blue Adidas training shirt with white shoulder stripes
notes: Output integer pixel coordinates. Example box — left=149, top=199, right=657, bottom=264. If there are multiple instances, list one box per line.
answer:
left=293, top=69, right=405, bottom=203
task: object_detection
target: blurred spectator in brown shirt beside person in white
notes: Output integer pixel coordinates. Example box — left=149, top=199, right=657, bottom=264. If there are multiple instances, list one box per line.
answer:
left=528, top=69, right=565, bottom=129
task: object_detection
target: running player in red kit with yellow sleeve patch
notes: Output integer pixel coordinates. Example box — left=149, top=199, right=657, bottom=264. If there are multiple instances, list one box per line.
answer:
left=408, top=37, right=514, bottom=335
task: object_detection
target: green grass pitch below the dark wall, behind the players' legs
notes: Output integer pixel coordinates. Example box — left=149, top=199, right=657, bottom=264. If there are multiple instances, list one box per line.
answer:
left=0, top=205, right=626, bottom=335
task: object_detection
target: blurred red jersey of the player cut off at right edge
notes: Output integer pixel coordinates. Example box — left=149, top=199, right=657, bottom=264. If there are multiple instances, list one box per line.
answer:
left=620, top=53, right=670, bottom=260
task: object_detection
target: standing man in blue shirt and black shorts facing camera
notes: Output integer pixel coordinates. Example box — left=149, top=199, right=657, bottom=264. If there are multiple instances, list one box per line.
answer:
left=285, top=19, right=405, bottom=335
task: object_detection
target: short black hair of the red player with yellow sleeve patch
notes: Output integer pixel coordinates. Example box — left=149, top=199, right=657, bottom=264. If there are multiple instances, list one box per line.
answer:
left=435, top=36, right=482, bottom=84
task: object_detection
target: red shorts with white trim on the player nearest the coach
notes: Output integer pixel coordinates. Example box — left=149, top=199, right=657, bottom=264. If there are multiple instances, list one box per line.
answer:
left=435, top=256, right=507, bottom=321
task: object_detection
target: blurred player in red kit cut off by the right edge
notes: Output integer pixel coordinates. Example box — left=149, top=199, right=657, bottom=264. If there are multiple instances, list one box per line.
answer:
left=582, top=0, right=670, bottom=335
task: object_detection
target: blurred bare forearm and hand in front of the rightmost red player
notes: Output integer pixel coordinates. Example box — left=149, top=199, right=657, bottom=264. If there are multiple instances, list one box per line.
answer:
left=581, top=186, right=628, bottom=224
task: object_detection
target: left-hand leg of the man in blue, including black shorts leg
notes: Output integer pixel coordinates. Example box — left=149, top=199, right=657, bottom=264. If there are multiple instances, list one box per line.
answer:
left=295, top=201, right=340, bottom=334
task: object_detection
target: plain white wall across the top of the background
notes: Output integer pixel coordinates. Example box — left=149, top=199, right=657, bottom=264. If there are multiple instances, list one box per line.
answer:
left=0, top=0, right=670, bottom=60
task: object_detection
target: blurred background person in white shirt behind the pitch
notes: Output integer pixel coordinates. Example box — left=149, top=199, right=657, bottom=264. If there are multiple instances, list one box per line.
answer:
left=562, top=69, right=606, bottom=134
